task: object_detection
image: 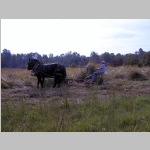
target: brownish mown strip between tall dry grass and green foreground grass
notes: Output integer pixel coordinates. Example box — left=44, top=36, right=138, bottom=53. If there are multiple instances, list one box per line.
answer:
left=1, top=80, right=150, bottom=105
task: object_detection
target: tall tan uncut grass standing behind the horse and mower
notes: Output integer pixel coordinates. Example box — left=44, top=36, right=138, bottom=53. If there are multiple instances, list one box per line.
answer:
left=1, top=64, right=150, bottom=88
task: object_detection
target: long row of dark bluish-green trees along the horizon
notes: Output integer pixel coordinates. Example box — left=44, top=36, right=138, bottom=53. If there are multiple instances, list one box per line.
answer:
left=1, top=48, right=150, bottom=68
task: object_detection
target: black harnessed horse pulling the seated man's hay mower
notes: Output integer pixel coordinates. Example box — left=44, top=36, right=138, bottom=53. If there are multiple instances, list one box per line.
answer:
left=27, top=58, right=66, bottom=88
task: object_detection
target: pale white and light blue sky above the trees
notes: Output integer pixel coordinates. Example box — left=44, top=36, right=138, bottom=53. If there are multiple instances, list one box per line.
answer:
left=1, top=19, right=150, bottom=56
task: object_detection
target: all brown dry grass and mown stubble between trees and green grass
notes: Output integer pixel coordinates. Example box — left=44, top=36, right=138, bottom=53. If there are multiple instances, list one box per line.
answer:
left=1, top=67, right=150, bottom=102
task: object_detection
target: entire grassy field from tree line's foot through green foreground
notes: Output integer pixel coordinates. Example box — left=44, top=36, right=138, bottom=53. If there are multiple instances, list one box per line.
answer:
left=1, top=67, right=150, bottom=132
